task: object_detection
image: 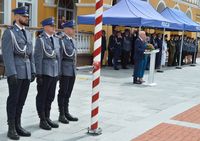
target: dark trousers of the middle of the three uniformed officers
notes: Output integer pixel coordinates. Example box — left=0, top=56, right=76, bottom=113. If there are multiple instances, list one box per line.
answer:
left=36, top=75, right=57, bottom=116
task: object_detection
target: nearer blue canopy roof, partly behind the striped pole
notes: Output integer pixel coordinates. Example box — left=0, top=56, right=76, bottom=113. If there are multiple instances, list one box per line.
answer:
left=78, top=0, right=183, bottom=30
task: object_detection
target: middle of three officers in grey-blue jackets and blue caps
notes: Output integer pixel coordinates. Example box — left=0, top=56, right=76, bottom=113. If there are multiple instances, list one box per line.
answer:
left=34, top=17, right=60, bottom=130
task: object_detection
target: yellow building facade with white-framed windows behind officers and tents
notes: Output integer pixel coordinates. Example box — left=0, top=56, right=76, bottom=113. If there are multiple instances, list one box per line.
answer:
left=0, top=0, right=200, bottom=65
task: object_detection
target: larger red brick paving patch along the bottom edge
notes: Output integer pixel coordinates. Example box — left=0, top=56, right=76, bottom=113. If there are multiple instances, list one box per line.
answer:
left=132, top=123, right=200, bottom=141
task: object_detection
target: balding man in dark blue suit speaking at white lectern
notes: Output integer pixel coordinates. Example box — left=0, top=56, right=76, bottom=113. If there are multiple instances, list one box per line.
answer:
left=133, top=31, right=146, bottom=84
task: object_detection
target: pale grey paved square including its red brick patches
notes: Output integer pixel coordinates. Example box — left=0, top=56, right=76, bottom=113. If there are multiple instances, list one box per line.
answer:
left=0, top=60, right=200, bottom=141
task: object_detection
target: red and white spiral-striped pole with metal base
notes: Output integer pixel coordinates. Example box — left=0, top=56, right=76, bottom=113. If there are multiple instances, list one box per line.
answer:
left=88, top=0, right=103, bottom=135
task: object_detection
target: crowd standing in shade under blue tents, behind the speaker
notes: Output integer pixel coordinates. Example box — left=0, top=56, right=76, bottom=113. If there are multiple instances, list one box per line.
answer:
left=101, top=29, right=198, bottom=70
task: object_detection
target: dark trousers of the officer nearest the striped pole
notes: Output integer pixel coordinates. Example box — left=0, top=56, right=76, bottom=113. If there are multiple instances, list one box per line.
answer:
left=58, top=76, right=76, bottom=110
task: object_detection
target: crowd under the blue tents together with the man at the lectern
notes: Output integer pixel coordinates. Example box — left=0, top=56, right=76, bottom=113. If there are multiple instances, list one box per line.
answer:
left=101, top=29, right=198, bottom=84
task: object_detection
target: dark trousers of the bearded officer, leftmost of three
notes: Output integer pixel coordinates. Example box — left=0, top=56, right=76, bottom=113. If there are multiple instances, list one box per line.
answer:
left=6, top=77, right=30, bottom=121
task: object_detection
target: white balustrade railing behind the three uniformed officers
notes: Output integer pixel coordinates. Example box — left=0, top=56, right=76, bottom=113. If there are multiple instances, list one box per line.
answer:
left=0, top=25, right=93, bottom=54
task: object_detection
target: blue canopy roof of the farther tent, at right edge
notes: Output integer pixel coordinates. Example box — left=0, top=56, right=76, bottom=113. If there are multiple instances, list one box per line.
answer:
left=161, top=7, right=200, bottom=32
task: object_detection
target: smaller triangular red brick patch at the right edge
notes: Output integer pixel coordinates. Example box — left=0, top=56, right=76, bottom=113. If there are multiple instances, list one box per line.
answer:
left=172, top=104, right=200, bottom=124
